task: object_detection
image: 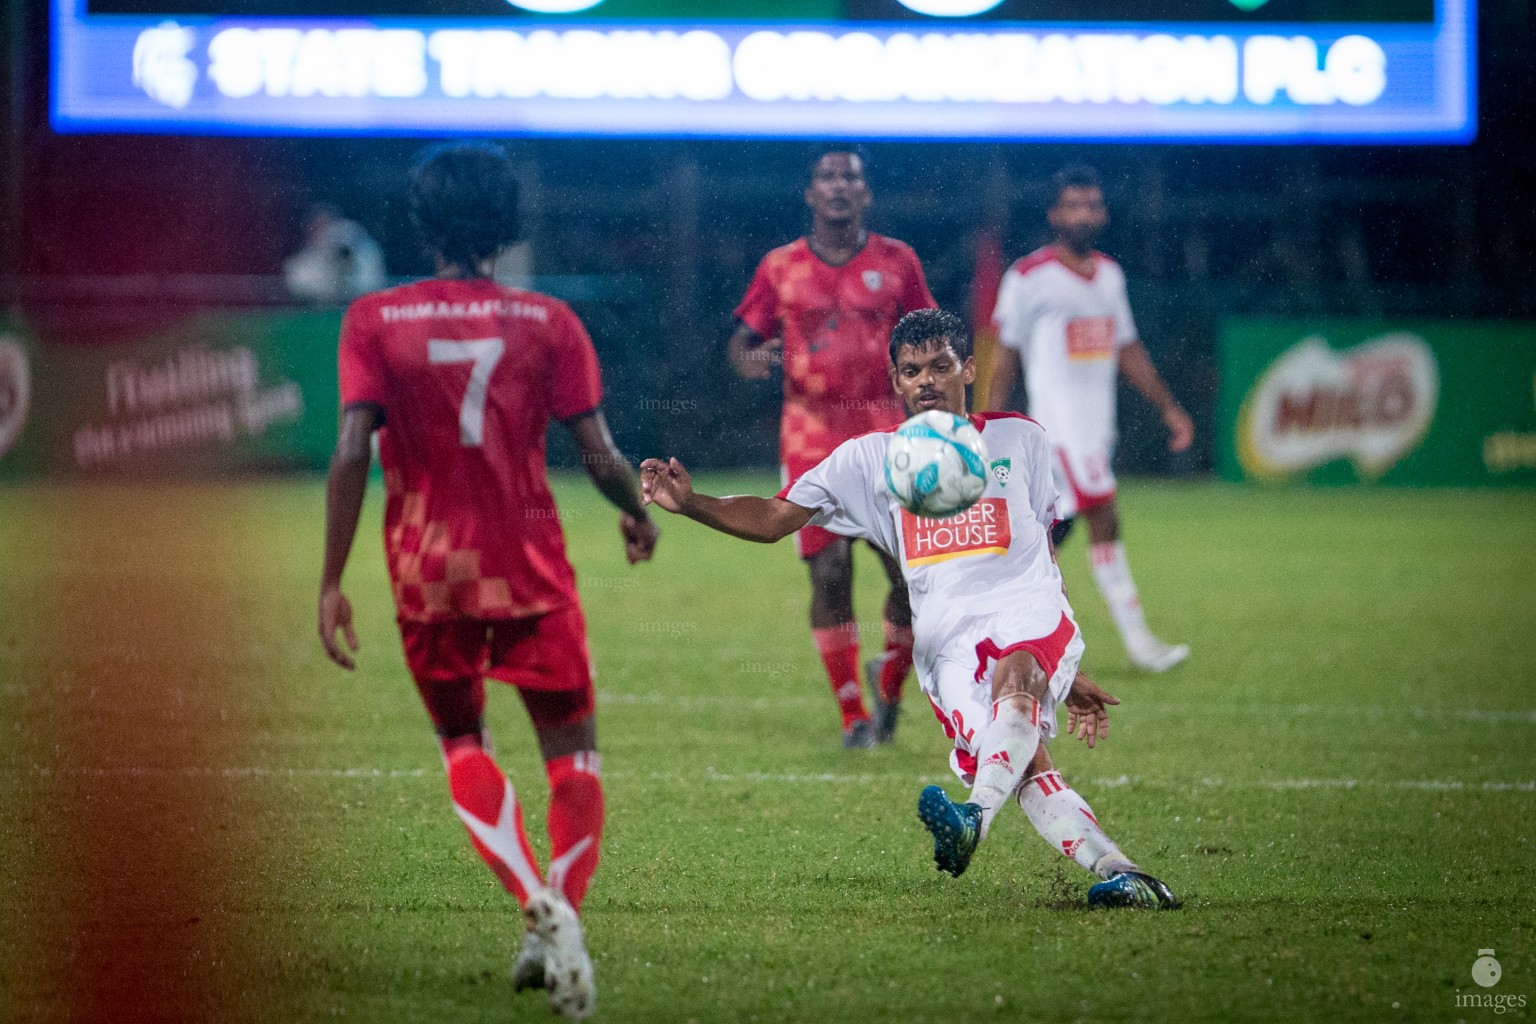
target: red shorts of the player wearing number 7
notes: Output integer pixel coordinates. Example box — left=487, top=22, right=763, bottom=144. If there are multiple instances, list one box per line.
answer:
left=399, top=602, right=593, bottom=728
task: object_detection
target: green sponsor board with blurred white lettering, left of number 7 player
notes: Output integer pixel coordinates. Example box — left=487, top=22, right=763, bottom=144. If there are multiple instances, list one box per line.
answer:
left=0, top=312, right=341, bottom=477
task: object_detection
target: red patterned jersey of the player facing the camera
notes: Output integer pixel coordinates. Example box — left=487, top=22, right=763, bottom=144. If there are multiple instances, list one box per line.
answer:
left=736, top=232, right=935, bottom=477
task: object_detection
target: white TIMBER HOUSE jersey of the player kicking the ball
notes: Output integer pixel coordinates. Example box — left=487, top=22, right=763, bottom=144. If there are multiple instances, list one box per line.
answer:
left=782, top=413, right=1071, bottom=669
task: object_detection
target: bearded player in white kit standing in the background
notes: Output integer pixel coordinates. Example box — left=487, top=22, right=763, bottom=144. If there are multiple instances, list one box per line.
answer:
left=986, top=164, right=1195, bottom=672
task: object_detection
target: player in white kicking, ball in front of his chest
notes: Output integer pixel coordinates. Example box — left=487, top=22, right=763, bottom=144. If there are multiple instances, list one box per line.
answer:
left=641, top=310, right=1177, bottom=907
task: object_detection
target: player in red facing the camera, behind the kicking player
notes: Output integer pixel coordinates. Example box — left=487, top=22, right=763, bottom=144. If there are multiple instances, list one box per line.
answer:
left=730, top=146, right=934, bottom=748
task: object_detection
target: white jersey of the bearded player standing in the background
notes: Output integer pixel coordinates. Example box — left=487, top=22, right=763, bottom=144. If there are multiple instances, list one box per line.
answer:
left=992, top=246, right=1137, bottom=450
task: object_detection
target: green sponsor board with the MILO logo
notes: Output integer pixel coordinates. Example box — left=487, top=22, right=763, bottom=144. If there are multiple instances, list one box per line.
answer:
left=1217, top=319, right=1536, bottom=487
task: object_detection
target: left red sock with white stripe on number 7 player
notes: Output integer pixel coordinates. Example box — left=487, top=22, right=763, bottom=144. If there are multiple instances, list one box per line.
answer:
left=444, top=742, right=542, bottom=904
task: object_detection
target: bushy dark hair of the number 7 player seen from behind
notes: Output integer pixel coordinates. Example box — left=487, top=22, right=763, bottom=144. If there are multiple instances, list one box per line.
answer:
left=410, top=143, right=521, bottom=272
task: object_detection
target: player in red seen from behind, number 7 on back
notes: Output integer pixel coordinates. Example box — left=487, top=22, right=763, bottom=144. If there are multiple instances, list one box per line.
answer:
left=319, top=144, right=656, bottom=1018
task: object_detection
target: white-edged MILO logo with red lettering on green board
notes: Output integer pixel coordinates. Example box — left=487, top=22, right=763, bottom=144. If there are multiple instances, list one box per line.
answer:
left=1236, top=333, right=1439, bottom=479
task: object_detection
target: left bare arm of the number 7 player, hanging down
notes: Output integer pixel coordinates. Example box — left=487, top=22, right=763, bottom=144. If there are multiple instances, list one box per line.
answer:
left=319, top=405, right=379, bottom=669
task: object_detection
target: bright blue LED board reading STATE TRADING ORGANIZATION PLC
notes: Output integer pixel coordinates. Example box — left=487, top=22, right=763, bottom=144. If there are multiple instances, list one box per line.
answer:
left=51, top=0, right=1476, bottom=143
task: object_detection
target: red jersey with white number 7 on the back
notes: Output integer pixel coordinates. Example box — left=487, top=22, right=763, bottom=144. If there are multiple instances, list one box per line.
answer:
left=339, top=279, right=602, bottom=622
